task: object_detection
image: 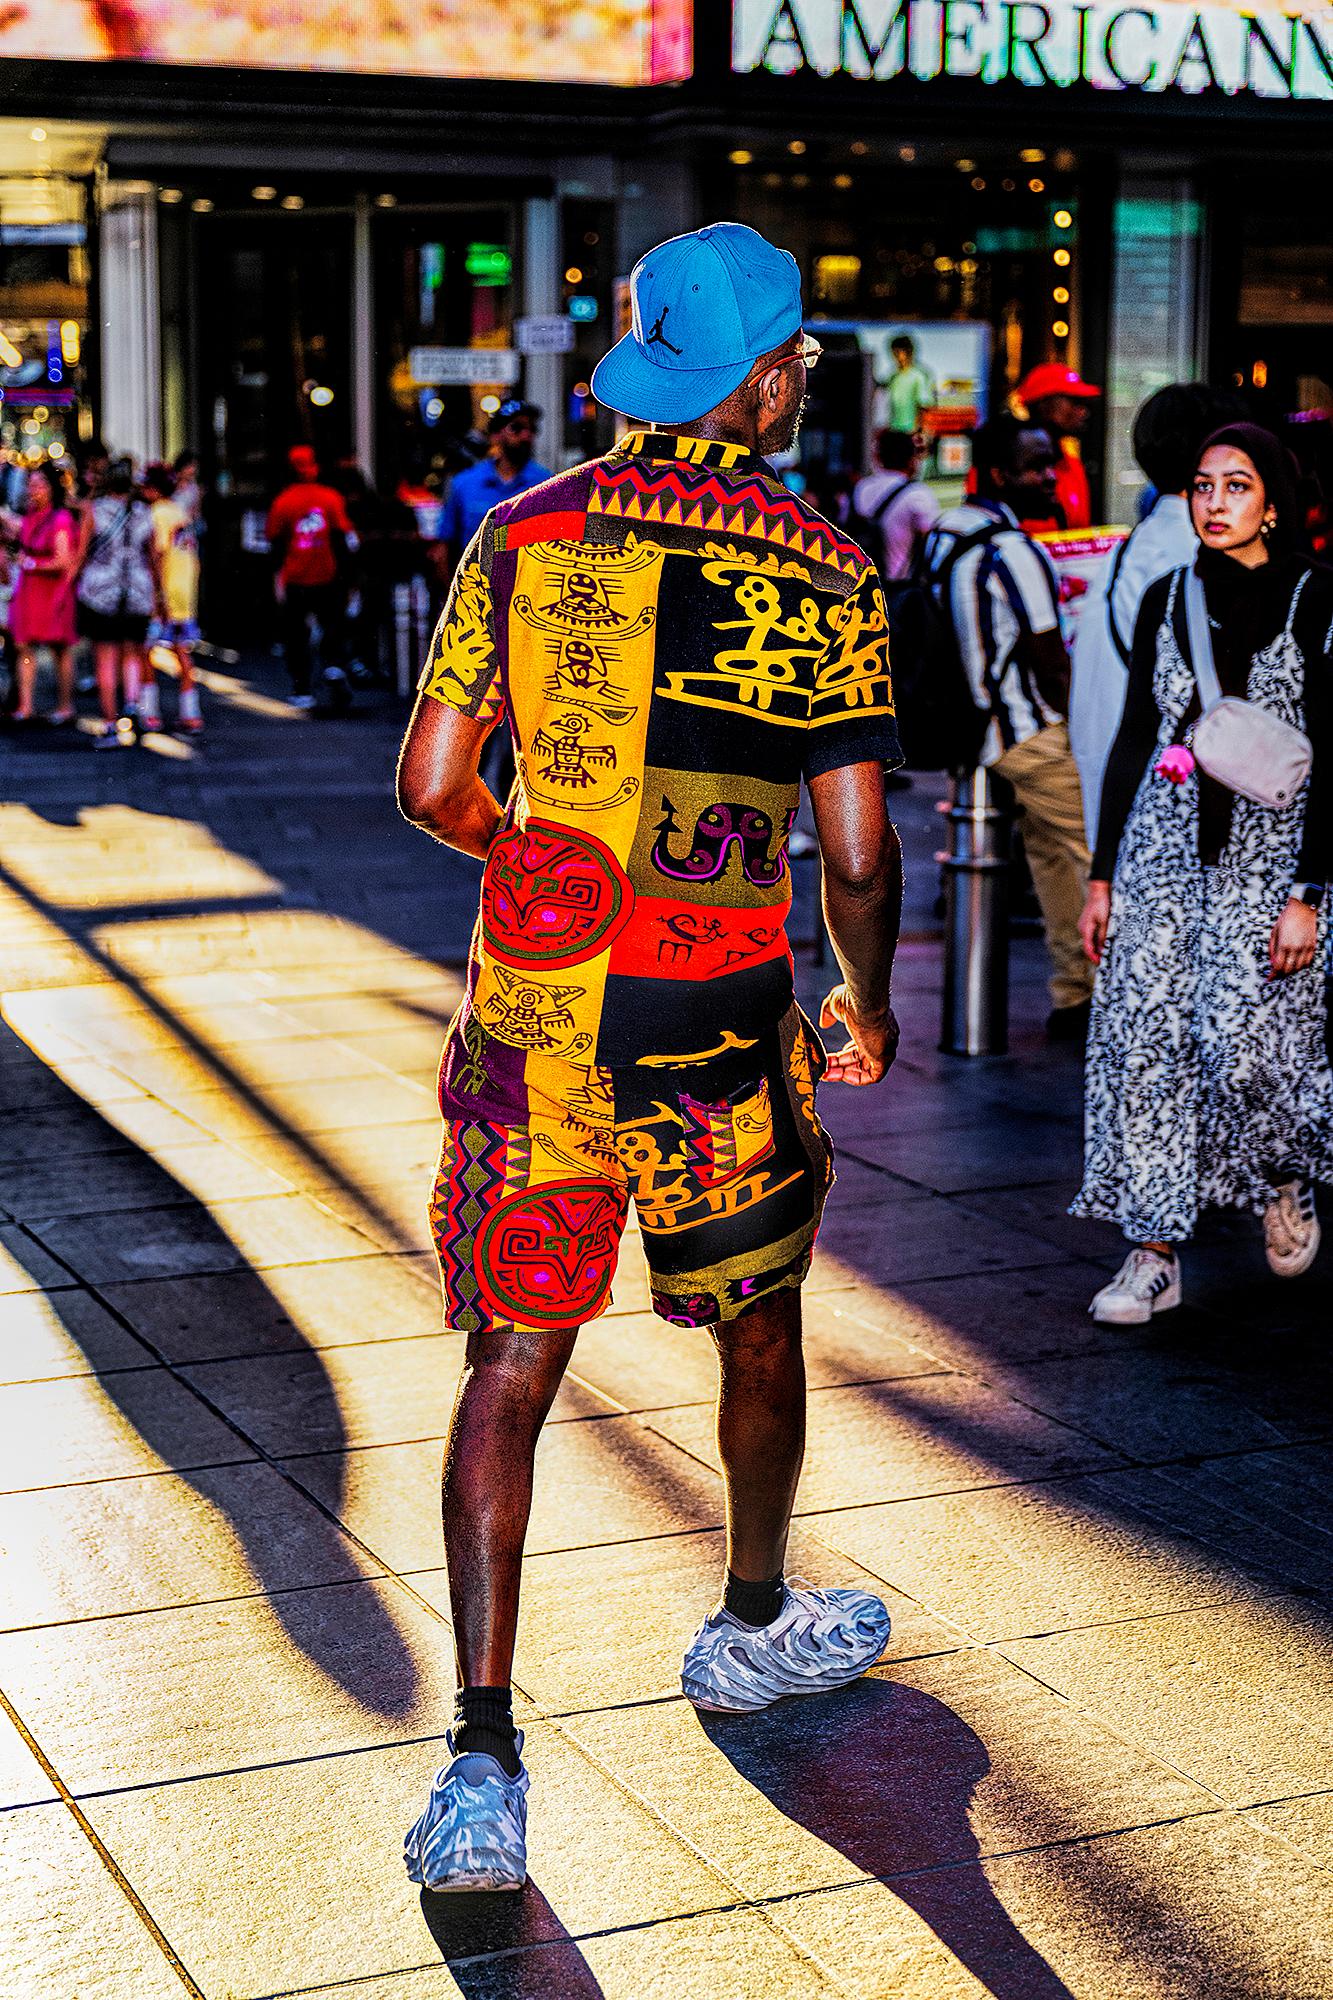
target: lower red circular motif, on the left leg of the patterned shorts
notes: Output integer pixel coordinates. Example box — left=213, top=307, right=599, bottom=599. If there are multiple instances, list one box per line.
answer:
left=472, top=1180, right=628, bottom=1326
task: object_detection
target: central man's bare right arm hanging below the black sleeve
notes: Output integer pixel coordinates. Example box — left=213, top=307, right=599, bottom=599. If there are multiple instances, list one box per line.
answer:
left=811, top=764, right=903, bottom=1084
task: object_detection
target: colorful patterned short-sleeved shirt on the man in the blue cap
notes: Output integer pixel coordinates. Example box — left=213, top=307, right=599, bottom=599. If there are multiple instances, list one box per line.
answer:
left=420, top=432, right=901, bottom=1088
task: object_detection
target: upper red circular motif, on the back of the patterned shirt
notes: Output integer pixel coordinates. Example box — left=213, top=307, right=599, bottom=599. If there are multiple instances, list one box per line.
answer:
left=482, top=820, right=634, bottom=968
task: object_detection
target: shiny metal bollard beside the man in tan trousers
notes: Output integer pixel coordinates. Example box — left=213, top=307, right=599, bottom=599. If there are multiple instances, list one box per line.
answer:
left=935, top=770, right=1013, bottom=1056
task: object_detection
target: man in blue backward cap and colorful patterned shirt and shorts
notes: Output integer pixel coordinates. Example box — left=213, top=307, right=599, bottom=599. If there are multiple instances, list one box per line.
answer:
left=398, top=222, right=903, bottom=1890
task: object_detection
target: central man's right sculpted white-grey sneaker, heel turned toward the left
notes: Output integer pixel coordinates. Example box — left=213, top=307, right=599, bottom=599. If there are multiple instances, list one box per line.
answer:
left=681, top=1580, right=889, bottom=1716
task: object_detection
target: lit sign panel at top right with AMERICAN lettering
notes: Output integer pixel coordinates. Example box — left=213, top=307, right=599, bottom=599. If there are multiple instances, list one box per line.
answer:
left=733, top=0, right=1333, bottom=100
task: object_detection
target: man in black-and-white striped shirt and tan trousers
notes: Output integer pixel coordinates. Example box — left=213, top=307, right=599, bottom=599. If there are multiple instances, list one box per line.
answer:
left=927, top=416, right=1093, bottom=1042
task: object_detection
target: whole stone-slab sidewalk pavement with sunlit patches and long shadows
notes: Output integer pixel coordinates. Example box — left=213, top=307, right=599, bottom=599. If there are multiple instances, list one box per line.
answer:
left=0, top=676, right=1333, bottom=2000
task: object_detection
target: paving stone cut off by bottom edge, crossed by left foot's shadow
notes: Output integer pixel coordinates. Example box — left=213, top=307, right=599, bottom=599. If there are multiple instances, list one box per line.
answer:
left=290, top=1898, right=847, bottom=2000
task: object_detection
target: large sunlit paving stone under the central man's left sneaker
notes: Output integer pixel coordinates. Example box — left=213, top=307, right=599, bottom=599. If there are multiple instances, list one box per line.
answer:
left=88, top=1724, right=731, bottom=2000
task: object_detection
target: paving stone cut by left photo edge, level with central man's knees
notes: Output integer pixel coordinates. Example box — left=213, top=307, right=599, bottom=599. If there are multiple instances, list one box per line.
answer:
left=0, top=1368, right=254, bottom=1492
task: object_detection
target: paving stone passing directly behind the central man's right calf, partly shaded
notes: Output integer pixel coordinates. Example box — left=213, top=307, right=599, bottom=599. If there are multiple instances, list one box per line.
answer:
left=644, top=1376, right=1119, bottom=1514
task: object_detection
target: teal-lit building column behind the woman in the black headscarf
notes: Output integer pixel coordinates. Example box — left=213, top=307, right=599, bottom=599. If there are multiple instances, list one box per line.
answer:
left=1107, top=170, right=1207, bottom=522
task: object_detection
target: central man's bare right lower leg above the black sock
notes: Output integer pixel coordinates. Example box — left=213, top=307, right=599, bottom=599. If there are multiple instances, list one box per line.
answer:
left=713, top=1288, right=805, bottom=1600
